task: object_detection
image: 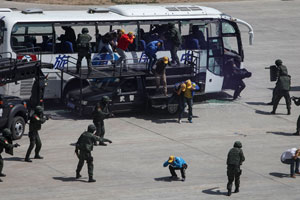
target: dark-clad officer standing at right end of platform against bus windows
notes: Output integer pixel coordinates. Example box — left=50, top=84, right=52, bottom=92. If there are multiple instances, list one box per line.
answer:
left=164, top=23, right=182, bottom=65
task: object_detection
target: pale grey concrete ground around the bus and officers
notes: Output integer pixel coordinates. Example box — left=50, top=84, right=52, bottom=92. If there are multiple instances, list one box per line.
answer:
left=0, top=0, right=300, bottom=200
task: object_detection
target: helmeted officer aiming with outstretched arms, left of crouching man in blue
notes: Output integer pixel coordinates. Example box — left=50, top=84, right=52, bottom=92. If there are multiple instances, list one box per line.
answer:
left=75, top=124, right=111, bottom=182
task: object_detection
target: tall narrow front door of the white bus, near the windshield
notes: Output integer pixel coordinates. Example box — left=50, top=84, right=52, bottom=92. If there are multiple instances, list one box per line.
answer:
left=205, top=21, right=224, bottom=93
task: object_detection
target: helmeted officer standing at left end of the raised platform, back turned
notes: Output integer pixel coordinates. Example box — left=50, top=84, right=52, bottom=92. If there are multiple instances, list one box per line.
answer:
left=76, top=28, right=92, bottom=74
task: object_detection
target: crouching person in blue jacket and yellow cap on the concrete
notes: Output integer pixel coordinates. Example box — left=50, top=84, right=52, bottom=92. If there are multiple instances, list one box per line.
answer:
left=164, top=156, right=187, bottom=181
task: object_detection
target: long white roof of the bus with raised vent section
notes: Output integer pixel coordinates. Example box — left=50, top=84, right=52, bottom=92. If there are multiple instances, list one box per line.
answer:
left=0, top=4, right=222, bottom=23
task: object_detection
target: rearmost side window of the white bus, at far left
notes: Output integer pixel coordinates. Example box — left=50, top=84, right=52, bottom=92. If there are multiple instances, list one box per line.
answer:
left=11, top=23, right=53, bottom=52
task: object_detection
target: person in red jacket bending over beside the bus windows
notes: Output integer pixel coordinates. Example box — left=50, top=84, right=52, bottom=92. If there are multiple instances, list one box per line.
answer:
left=116, top=32, right=135, bottom=70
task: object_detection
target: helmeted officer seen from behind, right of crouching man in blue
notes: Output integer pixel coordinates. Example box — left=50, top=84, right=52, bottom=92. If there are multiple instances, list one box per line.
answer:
left=227, top=141, right=245, bottom=196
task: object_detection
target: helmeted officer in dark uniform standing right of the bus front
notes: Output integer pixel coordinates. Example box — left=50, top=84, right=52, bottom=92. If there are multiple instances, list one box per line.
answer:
left=271, top=59, right=291, bottom=115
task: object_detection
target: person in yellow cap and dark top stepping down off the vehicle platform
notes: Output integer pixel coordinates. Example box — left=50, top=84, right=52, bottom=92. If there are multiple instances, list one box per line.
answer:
left=155, top=56, right=171, bottom=96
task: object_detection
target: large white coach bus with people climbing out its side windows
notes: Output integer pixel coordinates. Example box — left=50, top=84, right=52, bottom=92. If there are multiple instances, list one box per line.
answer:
left=0, top=5, right=253, bottom=98
